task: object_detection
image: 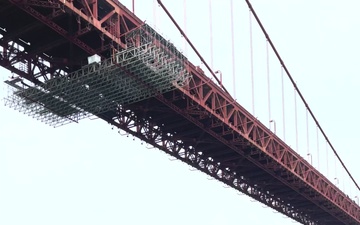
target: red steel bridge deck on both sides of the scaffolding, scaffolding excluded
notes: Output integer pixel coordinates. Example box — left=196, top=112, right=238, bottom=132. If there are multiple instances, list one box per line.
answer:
left=0, top=0, right=360, bottom=224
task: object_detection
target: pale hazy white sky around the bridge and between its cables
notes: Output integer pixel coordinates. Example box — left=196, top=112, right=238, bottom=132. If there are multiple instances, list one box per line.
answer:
left=0, top=0, right=360, bottom=225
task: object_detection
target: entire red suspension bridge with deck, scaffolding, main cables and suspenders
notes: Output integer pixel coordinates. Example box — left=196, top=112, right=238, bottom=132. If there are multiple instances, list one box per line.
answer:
left=0, top=0, right=360, bottom=224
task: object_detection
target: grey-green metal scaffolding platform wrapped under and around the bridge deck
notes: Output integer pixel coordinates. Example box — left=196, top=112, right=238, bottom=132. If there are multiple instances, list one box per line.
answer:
left=5, top=24, right=190, bottom=127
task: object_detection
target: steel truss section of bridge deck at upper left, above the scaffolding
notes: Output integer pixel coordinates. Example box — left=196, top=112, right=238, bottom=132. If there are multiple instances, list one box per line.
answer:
left=0, top=0, right=142, bottom=84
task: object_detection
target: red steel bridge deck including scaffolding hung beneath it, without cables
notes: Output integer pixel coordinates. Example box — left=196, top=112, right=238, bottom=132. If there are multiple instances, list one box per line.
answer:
left=0, top=0, right=360, bottom=225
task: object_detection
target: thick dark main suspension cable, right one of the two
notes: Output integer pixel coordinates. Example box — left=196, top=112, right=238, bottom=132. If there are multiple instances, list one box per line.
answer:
left=245, top=0, right=360, bottom=190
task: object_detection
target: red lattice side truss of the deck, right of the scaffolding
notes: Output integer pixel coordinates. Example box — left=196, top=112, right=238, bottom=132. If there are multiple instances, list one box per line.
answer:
left=171, top=64, right=360, bottom=224
